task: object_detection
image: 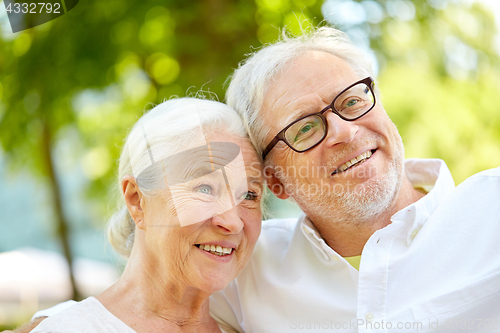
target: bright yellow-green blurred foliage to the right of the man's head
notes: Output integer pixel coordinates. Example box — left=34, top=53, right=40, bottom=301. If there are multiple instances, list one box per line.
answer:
left=324, top=0, right=500, bottom=184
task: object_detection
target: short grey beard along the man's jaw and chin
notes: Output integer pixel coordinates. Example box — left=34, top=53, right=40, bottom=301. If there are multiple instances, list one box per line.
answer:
left=280, top=136, right=404, bottom=225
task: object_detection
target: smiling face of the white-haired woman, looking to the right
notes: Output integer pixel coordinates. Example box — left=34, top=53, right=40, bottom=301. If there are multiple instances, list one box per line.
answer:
left=138, top=134, right=263, bottom=293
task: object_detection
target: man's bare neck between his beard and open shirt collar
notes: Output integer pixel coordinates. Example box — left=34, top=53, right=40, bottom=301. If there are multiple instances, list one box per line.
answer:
left=306, top=177, right=425, bottom=257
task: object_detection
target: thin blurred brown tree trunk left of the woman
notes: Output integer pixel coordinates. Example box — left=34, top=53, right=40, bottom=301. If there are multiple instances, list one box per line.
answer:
left=42, top=120, right=82, bottom=301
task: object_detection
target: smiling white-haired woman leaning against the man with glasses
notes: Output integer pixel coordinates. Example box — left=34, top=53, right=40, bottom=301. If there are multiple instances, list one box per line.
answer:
left=27, top=98, right=262, bottom=333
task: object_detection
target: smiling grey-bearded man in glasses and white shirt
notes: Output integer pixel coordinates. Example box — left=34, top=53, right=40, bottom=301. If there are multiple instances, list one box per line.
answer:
left=13, top=27, right=500, bottom=333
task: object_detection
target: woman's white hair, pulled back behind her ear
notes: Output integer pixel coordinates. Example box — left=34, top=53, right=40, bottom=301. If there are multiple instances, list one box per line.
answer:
left=108, top=98, right=247, bottom=258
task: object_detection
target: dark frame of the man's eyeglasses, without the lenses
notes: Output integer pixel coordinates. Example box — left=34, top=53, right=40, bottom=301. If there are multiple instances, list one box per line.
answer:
left=262, top=76, right=377, bottom=160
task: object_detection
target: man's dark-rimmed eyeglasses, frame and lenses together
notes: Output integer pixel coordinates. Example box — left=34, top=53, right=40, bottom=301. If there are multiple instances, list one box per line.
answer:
left=262, top=77, right=376, bottom=159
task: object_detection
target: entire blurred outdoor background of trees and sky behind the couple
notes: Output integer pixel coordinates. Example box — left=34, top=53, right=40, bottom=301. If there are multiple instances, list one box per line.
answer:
left=0, top=0, right=500, bottom=330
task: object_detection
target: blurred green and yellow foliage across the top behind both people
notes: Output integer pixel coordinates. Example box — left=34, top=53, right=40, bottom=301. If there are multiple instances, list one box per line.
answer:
left=0, top=0, right=500, bottom=290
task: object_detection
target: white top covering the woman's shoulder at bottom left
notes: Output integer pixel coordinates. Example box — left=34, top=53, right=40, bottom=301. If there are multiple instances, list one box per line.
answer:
left=31, top=297, right=135, bottom=333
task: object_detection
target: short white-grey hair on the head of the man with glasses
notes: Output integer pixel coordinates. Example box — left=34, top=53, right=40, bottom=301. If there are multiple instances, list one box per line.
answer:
left=226, top=27, right=373, bottom=156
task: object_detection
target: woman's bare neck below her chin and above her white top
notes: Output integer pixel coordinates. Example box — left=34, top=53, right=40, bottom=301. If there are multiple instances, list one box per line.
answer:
left=96, top=246, right=220, bottom=333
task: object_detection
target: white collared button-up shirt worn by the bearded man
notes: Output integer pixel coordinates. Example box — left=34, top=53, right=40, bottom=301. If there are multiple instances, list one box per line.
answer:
left=210, top=159, right=500, bottom=333
